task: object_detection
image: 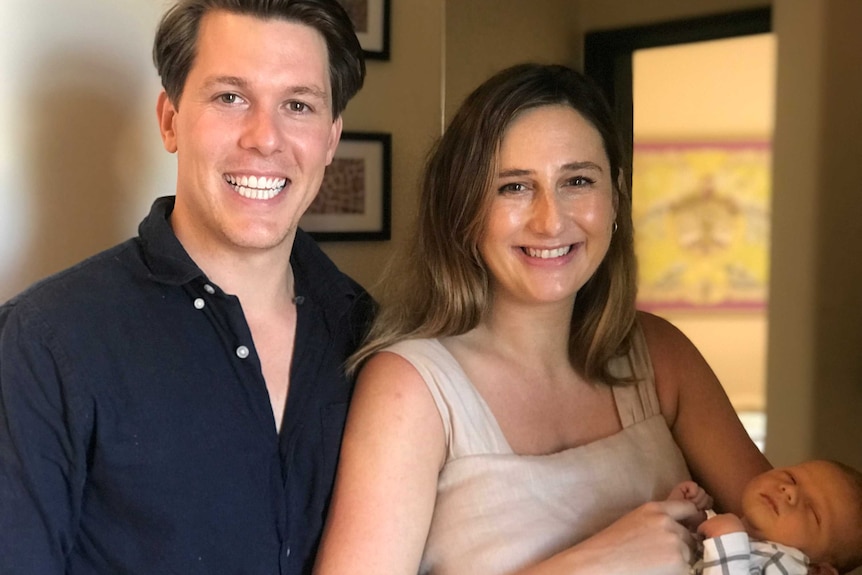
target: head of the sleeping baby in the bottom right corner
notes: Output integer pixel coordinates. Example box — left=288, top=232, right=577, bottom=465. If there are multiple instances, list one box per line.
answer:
left=742, top=460, right=862, bottom=573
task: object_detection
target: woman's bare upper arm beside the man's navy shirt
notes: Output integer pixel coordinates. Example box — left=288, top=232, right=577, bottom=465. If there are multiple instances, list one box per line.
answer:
left=314, top=353, right=445, bottom=575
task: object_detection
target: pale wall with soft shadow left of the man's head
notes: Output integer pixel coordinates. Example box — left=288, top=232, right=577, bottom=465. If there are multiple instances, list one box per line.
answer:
left=0, top=0, right=176, bottom=301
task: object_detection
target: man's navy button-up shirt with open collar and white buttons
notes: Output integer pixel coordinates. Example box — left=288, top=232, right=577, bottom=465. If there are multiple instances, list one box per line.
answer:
left=0, top=198, right=371, bottom=575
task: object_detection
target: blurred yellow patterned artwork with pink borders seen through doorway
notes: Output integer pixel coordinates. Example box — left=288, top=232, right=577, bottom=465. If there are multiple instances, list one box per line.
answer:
left=632, top=143, right=772, bottom=309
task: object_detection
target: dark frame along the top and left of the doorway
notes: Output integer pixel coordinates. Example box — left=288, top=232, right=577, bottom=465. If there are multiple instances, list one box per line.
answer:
left=584, top=6, right=772, bottom=189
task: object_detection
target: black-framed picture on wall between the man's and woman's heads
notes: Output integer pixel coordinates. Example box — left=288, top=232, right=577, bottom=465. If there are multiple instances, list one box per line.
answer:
left=299, top=132, right=392, bottom=241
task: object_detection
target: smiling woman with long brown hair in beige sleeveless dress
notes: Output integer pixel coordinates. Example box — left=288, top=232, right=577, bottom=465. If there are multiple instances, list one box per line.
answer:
left=317, top=64, right=769, bottom=575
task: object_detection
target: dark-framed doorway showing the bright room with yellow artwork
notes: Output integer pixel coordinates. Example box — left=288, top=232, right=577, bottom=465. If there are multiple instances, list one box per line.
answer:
left=585, top=9, right=775, bottom=449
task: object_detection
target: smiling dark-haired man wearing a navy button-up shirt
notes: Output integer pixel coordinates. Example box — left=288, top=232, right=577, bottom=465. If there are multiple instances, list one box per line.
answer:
left=0, top=0, right=371, bottom=575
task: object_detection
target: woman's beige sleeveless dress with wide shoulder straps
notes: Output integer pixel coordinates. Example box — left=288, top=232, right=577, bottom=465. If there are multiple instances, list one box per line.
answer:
left=387, top=330, right=689, bottom=575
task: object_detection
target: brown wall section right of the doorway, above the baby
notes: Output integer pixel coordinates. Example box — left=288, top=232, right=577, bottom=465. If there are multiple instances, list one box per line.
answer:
left=767, top=0, right=862, bottom=466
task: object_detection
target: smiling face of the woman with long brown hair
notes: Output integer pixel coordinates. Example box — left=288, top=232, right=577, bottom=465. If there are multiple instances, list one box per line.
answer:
left=479, top=105, right=616, bottom=303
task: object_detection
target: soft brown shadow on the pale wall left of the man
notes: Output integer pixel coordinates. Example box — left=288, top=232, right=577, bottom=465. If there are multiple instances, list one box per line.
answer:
left=8, top=53, right=144, bottom=299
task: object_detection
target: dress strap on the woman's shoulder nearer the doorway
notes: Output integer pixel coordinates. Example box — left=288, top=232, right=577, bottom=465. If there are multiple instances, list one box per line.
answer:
left=610, top=323, right=661, bottom=427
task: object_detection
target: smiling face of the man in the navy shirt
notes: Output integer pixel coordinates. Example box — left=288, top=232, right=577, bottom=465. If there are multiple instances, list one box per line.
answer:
left=158, top=11, right=341, bottom=255
